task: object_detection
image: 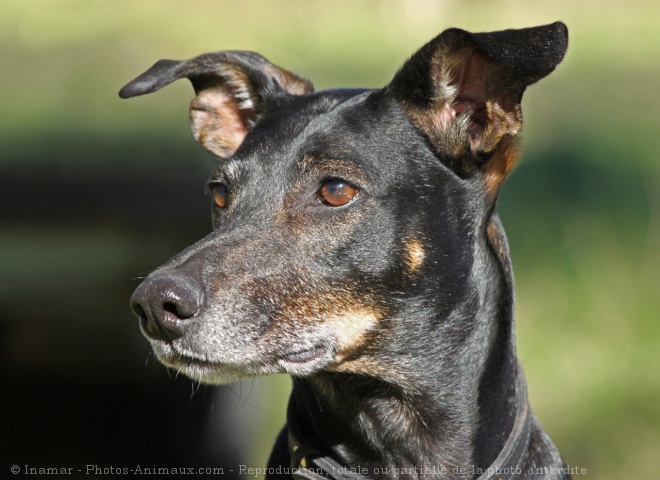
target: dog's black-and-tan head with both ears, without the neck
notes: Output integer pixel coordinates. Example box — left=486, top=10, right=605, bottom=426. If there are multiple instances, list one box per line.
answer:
left=120, top=23, right=567, bottom=383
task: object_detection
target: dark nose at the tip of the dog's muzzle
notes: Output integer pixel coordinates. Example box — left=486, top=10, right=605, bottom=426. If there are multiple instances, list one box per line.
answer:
left=131, top=273, right=204, bottom=341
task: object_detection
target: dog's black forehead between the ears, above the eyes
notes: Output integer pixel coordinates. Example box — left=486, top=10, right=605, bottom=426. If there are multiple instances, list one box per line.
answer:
left=219, top=90, right=411, bottom=182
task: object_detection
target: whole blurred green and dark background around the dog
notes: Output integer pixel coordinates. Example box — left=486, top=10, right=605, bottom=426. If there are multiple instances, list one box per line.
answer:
left=0, top=0, right=660, bottom=480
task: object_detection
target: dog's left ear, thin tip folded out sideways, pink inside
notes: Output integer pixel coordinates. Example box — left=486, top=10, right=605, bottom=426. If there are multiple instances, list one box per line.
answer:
left=119, top=51, right=314, bottom=159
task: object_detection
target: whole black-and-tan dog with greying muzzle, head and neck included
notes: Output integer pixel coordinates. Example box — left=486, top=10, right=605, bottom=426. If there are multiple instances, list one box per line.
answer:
left=120, top=22, right=570, bottom=480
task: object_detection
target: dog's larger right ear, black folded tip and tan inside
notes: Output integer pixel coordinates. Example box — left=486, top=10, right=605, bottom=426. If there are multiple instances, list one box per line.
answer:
left=385, top=22, right=568, bottom=194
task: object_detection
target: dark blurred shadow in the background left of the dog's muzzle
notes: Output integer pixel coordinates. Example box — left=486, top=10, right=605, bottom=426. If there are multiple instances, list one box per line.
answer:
left=0, top=135, right=244, bottom=478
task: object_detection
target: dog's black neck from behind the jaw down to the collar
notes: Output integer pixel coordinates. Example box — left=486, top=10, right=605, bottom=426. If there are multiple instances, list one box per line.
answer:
left=288, top=216, right=517, bottom=479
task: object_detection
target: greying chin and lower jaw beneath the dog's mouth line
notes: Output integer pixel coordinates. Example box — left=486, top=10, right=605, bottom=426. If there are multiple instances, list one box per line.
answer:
left=153, top=345, right=334, bottom=385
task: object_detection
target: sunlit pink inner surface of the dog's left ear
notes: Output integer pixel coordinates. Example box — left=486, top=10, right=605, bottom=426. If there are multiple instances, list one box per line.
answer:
left=189, top=88, right=248, bottom=159
